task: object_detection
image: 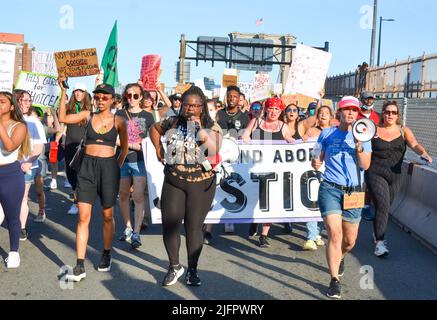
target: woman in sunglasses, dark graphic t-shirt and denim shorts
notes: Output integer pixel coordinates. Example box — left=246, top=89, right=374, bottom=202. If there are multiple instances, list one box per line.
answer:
left=116, top=83, right=155, bottom=249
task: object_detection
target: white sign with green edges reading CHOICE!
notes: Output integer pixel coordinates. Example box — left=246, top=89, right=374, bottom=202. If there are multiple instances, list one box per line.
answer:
left=16, top=71, right=61, bottom=108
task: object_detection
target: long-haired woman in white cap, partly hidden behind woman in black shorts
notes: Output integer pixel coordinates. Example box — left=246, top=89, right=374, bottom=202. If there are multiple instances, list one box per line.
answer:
left=65, top=82, right=93, bottom=215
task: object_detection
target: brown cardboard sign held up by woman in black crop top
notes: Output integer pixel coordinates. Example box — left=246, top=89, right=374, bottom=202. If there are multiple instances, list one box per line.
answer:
left=55, top=48, right=100, bottom=77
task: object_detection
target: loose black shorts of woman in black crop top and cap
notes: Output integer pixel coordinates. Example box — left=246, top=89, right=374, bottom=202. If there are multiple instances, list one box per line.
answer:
left=76, top=155, right=120, bottom=209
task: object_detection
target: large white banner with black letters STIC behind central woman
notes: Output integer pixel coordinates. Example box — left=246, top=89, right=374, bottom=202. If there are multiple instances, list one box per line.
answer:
left=143, top=138, right=322, bottom=223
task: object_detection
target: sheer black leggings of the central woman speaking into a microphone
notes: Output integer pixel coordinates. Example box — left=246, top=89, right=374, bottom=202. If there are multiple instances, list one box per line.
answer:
left=161, top=174, right=216, bottom=268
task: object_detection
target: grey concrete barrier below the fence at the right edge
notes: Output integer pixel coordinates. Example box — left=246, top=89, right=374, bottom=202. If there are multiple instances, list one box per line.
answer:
left=391, top=161, right=437, bottom=254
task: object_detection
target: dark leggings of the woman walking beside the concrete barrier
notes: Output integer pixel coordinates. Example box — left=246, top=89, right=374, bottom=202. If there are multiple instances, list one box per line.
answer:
left=366, top=167, right=401, bottom=241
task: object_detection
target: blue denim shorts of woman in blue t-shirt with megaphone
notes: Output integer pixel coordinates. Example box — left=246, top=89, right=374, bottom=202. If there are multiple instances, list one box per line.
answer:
left=319, top=182, right=362, bottom=224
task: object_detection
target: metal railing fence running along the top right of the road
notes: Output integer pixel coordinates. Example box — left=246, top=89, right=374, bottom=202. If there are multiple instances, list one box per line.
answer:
left=325, top=53, right=437, bottom=99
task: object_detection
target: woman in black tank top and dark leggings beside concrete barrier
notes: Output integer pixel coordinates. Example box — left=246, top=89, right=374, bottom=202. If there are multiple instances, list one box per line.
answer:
left=365, top=101, right=432, bottom=257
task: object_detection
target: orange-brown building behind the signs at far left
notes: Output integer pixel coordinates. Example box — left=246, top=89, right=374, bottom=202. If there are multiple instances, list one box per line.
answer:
left=0, top=33, right=35, bottom=83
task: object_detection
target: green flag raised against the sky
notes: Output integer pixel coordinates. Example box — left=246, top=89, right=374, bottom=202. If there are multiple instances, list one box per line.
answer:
left=100, top=21, right=119, bottom=88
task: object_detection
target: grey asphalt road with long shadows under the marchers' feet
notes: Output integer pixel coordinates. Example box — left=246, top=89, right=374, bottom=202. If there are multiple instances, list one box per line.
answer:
left=0, top=172, right=437, bottom=300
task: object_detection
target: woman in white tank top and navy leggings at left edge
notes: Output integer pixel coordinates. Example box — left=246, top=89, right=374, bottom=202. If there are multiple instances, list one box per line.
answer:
left=0, top=91, right=30, bottom=268
